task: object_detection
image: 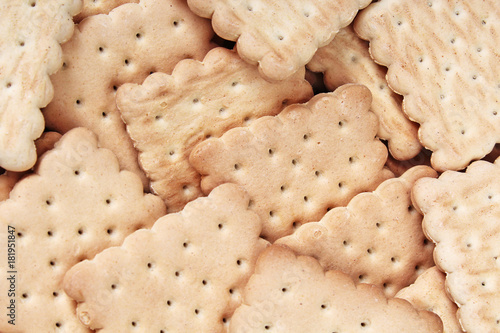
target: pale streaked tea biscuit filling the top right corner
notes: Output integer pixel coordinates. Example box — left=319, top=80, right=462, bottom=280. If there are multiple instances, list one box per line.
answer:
left=354, top=0, right=500, bottom=171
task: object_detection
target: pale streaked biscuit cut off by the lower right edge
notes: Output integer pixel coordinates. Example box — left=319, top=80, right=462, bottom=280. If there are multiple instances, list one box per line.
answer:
left=412, top=159, right=500, bottom=332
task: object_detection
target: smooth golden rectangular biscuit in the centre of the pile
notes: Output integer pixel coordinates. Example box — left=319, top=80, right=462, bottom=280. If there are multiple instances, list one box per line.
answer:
left=190, top=85, right=392, bottom=242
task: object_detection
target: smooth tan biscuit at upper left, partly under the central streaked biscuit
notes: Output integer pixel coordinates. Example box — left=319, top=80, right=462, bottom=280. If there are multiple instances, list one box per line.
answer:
left=44, top=0, right=213, bottom=188
